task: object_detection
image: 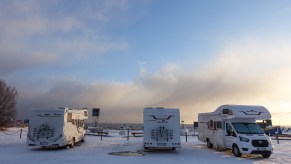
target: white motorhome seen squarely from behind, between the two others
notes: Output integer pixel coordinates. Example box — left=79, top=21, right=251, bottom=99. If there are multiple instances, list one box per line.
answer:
left=143, top=108, right=181, bottom=150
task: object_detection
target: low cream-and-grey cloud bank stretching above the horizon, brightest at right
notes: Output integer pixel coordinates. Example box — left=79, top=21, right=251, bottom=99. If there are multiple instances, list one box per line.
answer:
left=19, top=38, right=291, bottom=124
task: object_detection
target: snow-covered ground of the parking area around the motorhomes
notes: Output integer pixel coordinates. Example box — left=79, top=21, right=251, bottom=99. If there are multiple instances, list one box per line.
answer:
left=0, top=128, right=291, bottom=164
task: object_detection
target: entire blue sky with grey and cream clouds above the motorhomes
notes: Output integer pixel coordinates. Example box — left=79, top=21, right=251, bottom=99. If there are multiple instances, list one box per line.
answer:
left=0, top=0, right=291, bottom=125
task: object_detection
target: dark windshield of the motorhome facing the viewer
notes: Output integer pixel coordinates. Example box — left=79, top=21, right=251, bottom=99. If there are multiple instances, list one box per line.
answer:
left=232, top=123, right=264, bottom=134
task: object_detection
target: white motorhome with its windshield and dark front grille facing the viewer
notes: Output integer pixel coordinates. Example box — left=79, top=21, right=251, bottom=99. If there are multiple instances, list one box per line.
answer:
left=198, top=105, right=273, bottom=158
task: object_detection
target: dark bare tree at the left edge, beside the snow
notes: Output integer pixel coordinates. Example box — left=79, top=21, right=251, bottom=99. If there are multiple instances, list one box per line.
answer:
left=0, top=80, right=18, bottom=128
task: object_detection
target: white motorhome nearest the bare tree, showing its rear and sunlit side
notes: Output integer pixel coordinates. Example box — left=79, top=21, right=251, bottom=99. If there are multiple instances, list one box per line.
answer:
left=26, top=107, right=88, bottom=148
